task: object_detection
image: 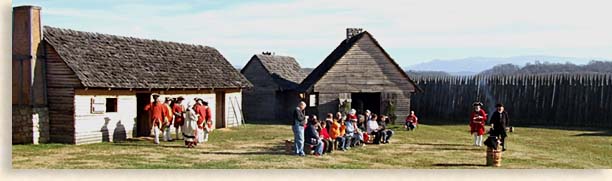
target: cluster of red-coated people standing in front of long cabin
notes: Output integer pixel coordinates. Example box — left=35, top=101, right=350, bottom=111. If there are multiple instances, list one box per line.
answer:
left=144, top=93, right=212, bottom=148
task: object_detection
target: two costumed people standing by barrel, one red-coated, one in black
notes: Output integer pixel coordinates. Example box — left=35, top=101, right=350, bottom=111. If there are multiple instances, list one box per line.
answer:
left=470, top=102, right=510, bottom=151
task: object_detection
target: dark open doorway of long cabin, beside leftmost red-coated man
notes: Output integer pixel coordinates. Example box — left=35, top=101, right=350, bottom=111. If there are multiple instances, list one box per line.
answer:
left=136, top=93, right=152, bottom=136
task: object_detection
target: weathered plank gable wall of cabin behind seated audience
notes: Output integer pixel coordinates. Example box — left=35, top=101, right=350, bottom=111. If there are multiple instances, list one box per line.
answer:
left=314, top=36, right=415, bottom=121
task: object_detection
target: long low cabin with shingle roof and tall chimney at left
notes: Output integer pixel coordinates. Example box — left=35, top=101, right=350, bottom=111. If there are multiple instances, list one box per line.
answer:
left=12, top=6, right=252, bottom=144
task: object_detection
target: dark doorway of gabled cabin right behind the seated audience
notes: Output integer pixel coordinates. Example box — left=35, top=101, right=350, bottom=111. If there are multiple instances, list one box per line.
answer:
left=351, top=92, right=381, bottom=114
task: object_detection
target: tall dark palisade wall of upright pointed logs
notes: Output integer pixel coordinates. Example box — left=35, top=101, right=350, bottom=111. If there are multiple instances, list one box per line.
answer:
left=411, top=73, right=612, bottom=128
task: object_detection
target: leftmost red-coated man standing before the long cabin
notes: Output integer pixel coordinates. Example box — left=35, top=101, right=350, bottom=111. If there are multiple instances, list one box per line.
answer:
left=144, top=94, right=168, bottom=144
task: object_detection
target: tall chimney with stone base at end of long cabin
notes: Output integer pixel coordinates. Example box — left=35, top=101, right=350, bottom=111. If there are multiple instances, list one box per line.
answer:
left=12, top=6, right=49, bottom=144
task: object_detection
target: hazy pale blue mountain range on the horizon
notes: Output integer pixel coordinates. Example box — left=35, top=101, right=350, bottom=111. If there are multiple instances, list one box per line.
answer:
left=404, top=55, right=610, bottom=75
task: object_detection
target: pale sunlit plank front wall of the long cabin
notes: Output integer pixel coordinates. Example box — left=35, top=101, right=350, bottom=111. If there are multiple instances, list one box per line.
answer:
left=74, top=89, right=242, bottom=144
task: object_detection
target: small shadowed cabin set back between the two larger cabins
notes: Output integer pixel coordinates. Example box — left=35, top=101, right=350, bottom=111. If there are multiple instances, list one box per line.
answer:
left=240, top=52, right=307, bottom=123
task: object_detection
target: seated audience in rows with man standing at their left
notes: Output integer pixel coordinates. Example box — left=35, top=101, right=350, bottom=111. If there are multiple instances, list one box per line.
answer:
left=292, top=102, right=393, bottom=156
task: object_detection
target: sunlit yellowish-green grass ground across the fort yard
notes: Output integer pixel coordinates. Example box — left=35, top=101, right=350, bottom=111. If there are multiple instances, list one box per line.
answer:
left=12, top=124, right=612, bottom=169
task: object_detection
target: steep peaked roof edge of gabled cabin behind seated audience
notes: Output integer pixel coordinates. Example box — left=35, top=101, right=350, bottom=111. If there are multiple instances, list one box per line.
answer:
left=298, top=31, right=423, bottom=92
